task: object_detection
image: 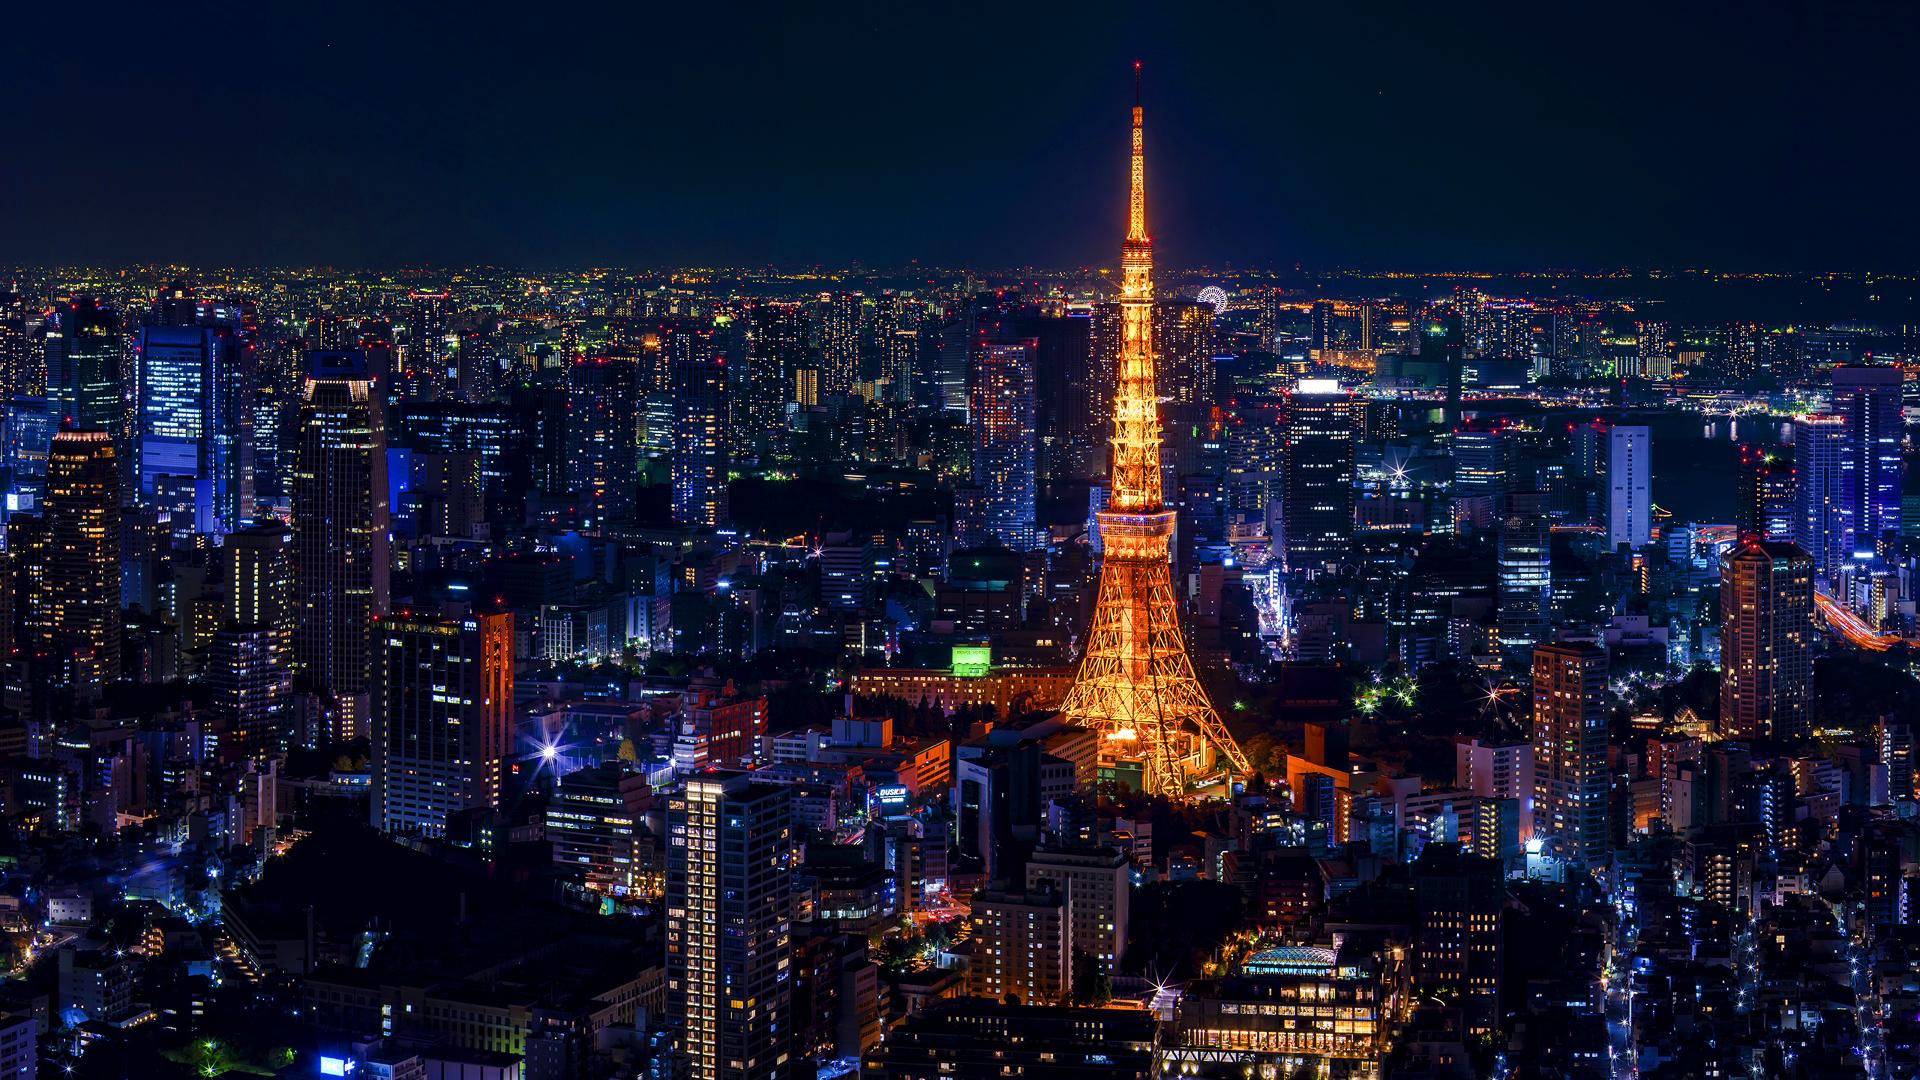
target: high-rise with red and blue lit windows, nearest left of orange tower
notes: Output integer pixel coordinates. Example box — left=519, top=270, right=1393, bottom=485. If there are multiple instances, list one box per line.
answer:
left=962, top=340, right=1041, bottom=552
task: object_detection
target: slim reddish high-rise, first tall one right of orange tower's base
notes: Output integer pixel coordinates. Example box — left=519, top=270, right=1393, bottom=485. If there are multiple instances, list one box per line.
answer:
left=1534, top=642, right=1611, bottom=871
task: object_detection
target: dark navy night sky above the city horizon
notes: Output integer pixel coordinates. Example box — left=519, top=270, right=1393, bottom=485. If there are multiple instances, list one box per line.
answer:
left=0, top=0, right=1920, bottom=269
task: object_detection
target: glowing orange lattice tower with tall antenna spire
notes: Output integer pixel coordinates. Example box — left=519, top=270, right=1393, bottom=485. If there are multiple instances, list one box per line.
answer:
left=1062, top=63, right=1248, bottom=798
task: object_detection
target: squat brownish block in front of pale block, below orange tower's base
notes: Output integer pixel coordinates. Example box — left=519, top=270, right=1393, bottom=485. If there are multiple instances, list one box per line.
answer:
left=966, top=884, right=1073, bottom=1005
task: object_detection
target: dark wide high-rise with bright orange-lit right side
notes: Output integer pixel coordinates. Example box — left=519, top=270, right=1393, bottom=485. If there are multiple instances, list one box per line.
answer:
left=372, top=613, right=513, bottom=836
